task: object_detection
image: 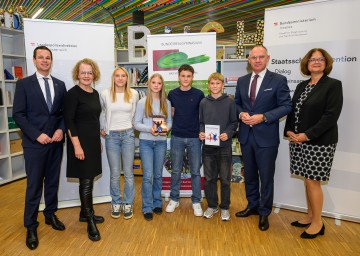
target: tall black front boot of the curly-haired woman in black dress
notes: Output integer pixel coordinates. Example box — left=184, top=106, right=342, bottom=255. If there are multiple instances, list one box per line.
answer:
left=79, top=179, right=101, bottom=241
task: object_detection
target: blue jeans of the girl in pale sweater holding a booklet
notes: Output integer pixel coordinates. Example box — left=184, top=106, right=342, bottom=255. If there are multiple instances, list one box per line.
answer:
left=140, top=140, right=166, bottom=213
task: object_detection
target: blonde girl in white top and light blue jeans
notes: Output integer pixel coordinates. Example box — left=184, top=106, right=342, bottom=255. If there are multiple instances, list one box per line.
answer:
left=100, top=67, right=139, bottom=219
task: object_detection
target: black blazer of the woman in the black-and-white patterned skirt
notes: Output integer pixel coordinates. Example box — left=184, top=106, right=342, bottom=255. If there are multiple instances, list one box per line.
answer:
left=284, top=75, right=343, bottom=145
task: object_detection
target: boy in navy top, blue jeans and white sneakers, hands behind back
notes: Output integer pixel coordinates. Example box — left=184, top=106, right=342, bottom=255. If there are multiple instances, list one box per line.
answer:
left=166, top=64, right=204, bottom=216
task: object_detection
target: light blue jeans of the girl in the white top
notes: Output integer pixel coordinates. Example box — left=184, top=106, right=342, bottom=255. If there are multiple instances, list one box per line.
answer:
left=105, top=128, right=135, bottom=204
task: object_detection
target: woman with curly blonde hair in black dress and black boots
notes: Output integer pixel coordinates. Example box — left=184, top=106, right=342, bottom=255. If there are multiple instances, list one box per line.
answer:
left=64, top=59, right=104, bottom=241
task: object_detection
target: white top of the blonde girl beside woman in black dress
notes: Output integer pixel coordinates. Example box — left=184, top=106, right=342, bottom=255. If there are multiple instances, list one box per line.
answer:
left=100, top=89, right=139, bottom=134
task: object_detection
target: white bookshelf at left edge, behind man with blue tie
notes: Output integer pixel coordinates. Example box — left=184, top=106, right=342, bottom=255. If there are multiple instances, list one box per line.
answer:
left=0, top=27, right=26, bottom=185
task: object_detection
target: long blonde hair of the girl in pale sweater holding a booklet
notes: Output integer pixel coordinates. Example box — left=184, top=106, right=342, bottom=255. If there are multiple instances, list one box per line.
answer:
left=145, top=73, right=168, bottom=118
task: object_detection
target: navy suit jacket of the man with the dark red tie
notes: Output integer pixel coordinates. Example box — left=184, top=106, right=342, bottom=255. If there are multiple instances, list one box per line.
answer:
left=235, top=70, right=292, bottom=147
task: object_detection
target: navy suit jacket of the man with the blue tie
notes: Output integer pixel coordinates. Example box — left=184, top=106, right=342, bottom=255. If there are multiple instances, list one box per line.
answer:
left=13, top=74, right=66, bottom=148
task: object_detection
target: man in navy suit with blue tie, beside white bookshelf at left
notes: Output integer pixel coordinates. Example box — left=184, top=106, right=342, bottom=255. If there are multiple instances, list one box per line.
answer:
left=13, top=46, right=66, bottom=250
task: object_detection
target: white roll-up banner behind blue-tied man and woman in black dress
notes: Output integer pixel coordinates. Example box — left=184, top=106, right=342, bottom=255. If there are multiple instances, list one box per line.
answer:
left=24, top=19, right=115, bottom=208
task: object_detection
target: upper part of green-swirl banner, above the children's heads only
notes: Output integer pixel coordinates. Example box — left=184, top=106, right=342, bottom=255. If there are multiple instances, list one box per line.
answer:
left=147, top=32, right=216, bottom=95
